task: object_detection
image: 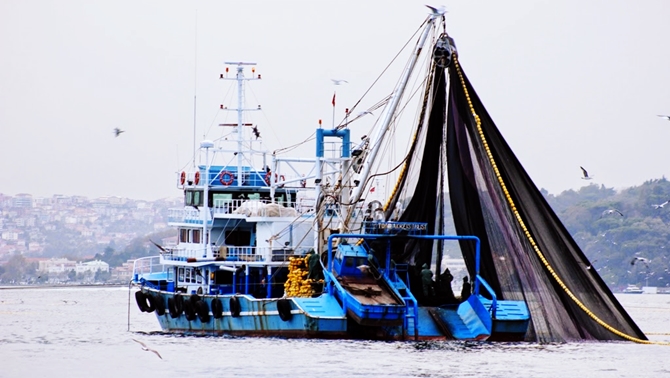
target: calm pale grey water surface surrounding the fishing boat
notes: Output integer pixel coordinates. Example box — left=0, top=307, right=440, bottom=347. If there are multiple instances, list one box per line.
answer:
left=0, top=287, right=670, bottom=378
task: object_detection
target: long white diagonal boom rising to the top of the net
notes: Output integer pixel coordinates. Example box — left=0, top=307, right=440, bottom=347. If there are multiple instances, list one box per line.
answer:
left=343, top=12, right=444, bottom=227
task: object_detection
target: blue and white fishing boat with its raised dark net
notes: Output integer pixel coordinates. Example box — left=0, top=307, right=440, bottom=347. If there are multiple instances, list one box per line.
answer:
left=132, top=8, right=644, bottom=341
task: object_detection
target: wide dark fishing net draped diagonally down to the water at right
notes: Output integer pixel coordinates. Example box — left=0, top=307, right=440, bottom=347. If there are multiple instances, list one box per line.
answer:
left=444, top=59, right=646, bottom=342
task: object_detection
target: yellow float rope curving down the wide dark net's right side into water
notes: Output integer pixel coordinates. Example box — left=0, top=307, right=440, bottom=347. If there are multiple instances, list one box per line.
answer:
left=454, top=56, right=670, bottom=346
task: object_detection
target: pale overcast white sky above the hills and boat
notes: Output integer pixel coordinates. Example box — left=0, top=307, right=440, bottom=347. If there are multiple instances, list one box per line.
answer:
left=0, top=0, right=670, bottom=200
